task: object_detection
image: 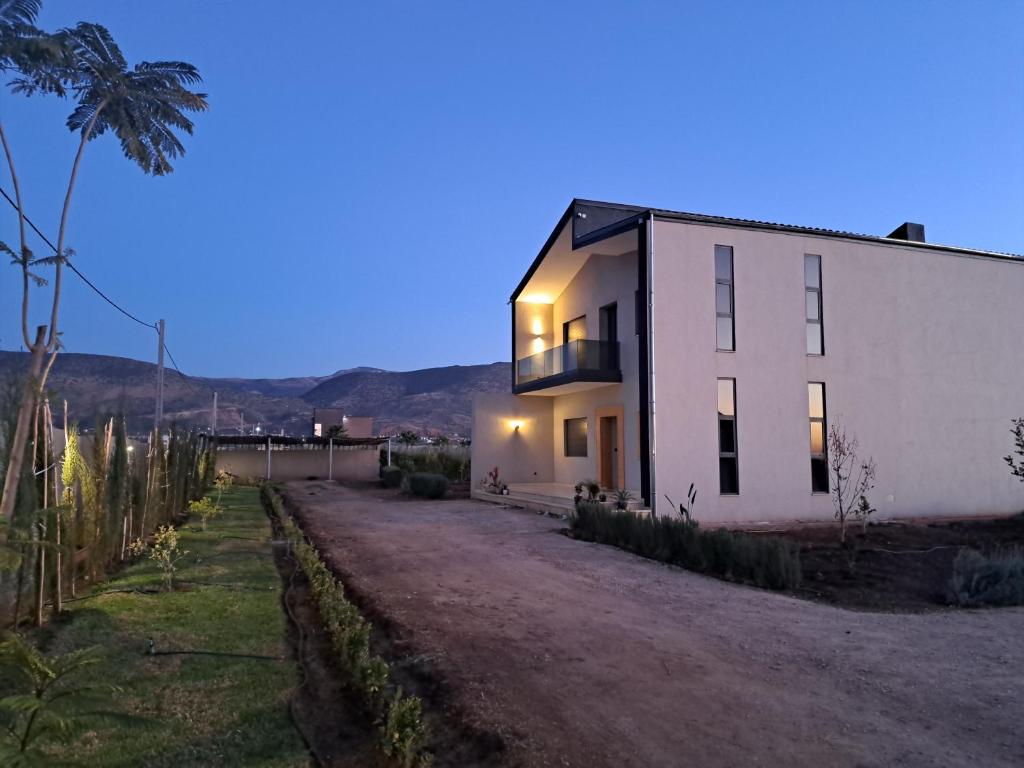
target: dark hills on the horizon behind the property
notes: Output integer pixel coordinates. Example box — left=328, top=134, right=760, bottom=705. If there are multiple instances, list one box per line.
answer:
left=0, top=351, right=511, bottom=434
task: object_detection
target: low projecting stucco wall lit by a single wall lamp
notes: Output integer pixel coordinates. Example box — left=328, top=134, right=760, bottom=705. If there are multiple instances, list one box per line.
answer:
left=470, top=392, right=554, bottom=489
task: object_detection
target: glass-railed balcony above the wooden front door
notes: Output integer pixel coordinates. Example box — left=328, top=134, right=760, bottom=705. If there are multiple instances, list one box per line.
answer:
left=512, top=339, right=623, bottom=394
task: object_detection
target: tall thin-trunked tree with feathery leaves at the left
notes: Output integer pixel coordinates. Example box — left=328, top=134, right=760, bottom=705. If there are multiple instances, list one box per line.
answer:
left=0, top=0, right=207, bottom=519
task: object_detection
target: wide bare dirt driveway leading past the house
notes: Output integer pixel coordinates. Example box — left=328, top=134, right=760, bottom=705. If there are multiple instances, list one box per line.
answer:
left=287, top=482, right=1024, bottom=768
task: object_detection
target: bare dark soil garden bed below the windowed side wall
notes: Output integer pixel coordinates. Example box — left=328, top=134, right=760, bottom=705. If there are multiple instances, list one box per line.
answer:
left=773, top=514, right=1024, bottom=611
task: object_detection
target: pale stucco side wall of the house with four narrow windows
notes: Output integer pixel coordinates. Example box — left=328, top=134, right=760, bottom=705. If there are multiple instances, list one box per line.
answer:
left=652, top=221, right=1024, bottom=521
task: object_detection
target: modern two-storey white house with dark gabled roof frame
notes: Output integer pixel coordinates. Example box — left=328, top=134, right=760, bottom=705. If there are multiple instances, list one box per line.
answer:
left=472, top=201, right=1024, bottom=522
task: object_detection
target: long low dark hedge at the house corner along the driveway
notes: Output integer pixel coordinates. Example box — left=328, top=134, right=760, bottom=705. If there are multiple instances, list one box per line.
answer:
left=571, top=502, right=800, bottom=590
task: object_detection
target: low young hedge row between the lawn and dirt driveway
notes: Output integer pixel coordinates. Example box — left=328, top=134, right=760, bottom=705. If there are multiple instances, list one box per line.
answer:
left=261, top=483, right=432, bottom=768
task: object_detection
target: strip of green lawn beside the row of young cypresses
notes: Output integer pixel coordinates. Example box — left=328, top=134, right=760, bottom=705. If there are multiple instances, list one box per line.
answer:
left=30, top=487, right=309, bottom=768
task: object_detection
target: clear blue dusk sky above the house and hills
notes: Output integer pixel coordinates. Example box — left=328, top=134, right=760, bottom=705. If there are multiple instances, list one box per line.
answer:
left=0, top=0, right=1024, bottom=377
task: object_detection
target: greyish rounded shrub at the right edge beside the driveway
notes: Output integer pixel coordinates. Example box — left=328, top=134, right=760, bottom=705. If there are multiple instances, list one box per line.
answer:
left=948, top=547, right=1024, bottom=607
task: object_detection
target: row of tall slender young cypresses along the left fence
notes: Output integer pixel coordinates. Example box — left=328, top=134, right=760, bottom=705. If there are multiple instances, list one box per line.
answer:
left=0, top=384, right=215, bottom=628
